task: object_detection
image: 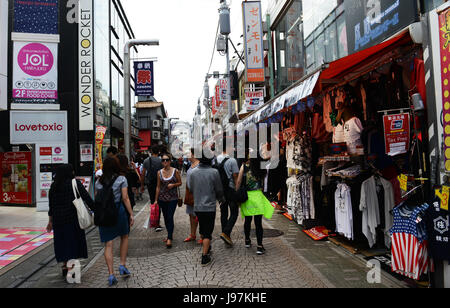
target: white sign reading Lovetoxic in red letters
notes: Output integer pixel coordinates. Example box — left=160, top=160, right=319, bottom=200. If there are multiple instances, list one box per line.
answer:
left=10, top=111, right=67, bottom=144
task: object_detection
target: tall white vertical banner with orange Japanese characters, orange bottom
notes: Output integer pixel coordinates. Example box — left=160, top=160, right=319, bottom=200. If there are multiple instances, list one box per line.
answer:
left=242, top=1, right=266, bottom=82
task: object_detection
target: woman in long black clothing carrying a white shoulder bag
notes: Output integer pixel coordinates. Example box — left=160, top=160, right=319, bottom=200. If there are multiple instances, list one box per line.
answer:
left=47, top=164, right=94, bottom=277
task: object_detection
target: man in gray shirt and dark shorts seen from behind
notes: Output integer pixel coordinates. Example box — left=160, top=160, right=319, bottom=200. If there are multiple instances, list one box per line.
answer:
left=187, top=158, right=223, bottom=266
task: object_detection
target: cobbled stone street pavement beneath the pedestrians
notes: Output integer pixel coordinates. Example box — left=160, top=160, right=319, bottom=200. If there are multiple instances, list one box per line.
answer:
left=7, top=176, right=404, bottom=288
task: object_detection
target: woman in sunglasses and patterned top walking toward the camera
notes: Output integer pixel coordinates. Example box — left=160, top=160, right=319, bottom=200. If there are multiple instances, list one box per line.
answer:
left=156, top=154, right=182, bottom=249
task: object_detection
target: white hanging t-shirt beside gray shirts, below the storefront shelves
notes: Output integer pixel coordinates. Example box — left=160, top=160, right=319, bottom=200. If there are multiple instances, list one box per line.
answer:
left=335, top=184, right=354, bottom=240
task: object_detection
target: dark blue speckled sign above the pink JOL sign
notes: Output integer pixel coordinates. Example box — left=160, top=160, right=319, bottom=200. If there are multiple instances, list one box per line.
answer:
left=14, top=0, right=59, bottom=34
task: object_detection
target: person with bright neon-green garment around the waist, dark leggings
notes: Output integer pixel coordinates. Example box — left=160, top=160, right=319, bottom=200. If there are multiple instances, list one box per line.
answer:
left=236, top=154, right=274, bottom=255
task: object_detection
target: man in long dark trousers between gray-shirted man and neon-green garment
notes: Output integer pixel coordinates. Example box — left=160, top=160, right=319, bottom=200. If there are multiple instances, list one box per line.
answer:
left=217, top=151, right=239, bottom=246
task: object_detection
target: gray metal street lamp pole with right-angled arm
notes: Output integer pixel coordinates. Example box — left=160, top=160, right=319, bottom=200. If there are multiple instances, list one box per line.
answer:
left=123, top=39, right=159, bottom=159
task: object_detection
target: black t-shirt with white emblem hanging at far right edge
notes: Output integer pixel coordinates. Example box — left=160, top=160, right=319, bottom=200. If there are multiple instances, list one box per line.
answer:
left=425, top=199, right=450, bottom=261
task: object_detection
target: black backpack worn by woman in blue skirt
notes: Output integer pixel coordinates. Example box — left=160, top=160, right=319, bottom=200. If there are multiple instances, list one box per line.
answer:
left=94, top=177, right=119, bottom=227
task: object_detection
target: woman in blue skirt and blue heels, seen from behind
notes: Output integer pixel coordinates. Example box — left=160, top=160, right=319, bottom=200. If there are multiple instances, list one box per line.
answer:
left=95, top=157, right=134, bottom=286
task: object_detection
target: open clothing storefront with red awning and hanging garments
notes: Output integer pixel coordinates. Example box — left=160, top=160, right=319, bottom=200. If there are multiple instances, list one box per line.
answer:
left=238, top=23, right=450, bottom=286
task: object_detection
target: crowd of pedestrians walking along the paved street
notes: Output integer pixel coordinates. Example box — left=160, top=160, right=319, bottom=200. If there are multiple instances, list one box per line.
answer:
left=47, top=141, right=273, bottom=286
